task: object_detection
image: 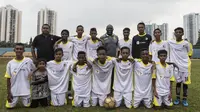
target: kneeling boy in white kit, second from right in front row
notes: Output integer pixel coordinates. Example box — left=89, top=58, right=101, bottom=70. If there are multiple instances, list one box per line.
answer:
left=133, top=49, right=153, bottom=108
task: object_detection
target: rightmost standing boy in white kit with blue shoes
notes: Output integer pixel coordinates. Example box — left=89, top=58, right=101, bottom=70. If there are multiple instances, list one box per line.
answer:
left=168, top=27, right=192, bottom=107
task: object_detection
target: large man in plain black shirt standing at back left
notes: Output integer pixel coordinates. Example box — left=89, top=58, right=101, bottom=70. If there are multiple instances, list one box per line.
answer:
left=31, top=24, right=61, bottom=61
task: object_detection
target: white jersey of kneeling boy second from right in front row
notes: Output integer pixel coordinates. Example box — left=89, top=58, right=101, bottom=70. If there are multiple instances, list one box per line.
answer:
left=134, top=60, right=152, bottom=98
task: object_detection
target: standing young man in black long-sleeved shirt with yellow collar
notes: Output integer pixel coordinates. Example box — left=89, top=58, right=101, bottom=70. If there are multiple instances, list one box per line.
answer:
left=132, top=22, right=152, bottom=58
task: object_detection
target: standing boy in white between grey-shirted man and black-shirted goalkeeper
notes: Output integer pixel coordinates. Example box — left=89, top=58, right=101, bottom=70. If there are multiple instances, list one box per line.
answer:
left=117, top=28, right=132, bottom=57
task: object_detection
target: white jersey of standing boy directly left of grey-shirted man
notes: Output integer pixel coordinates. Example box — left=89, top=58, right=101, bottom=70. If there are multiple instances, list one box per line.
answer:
left=86, top=38, right=102, bottom=60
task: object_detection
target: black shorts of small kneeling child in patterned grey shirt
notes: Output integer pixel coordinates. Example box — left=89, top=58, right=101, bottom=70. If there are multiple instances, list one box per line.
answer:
left=30, top=98, right=48, bottom=108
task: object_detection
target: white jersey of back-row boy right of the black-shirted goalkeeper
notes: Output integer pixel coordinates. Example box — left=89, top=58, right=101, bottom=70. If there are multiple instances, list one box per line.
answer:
left=149, top=40, right=169, bottom=62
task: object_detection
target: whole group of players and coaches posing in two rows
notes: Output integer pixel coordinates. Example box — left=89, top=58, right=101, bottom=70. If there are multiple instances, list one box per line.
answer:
left=5, top=22, right=193, bottom=109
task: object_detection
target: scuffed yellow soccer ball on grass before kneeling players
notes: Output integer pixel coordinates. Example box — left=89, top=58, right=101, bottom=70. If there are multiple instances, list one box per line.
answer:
left=104, top=97, right=115, bottom=109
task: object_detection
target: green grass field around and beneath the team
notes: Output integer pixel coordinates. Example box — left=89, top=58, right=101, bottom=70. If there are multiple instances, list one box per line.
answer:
left=0, top=59, right=200, bottom=112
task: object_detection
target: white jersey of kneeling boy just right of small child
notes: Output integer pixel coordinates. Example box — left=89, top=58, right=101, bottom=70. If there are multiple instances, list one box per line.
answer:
left=47, top=60, right=72, bottom=94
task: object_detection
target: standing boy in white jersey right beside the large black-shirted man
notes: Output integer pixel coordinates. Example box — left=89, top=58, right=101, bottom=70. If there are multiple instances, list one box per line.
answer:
left=54, top=29, right=74, bottom=60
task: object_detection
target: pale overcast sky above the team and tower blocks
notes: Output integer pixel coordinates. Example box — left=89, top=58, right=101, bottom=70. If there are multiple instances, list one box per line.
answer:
left=0, top=0, right=200, bottom=42
